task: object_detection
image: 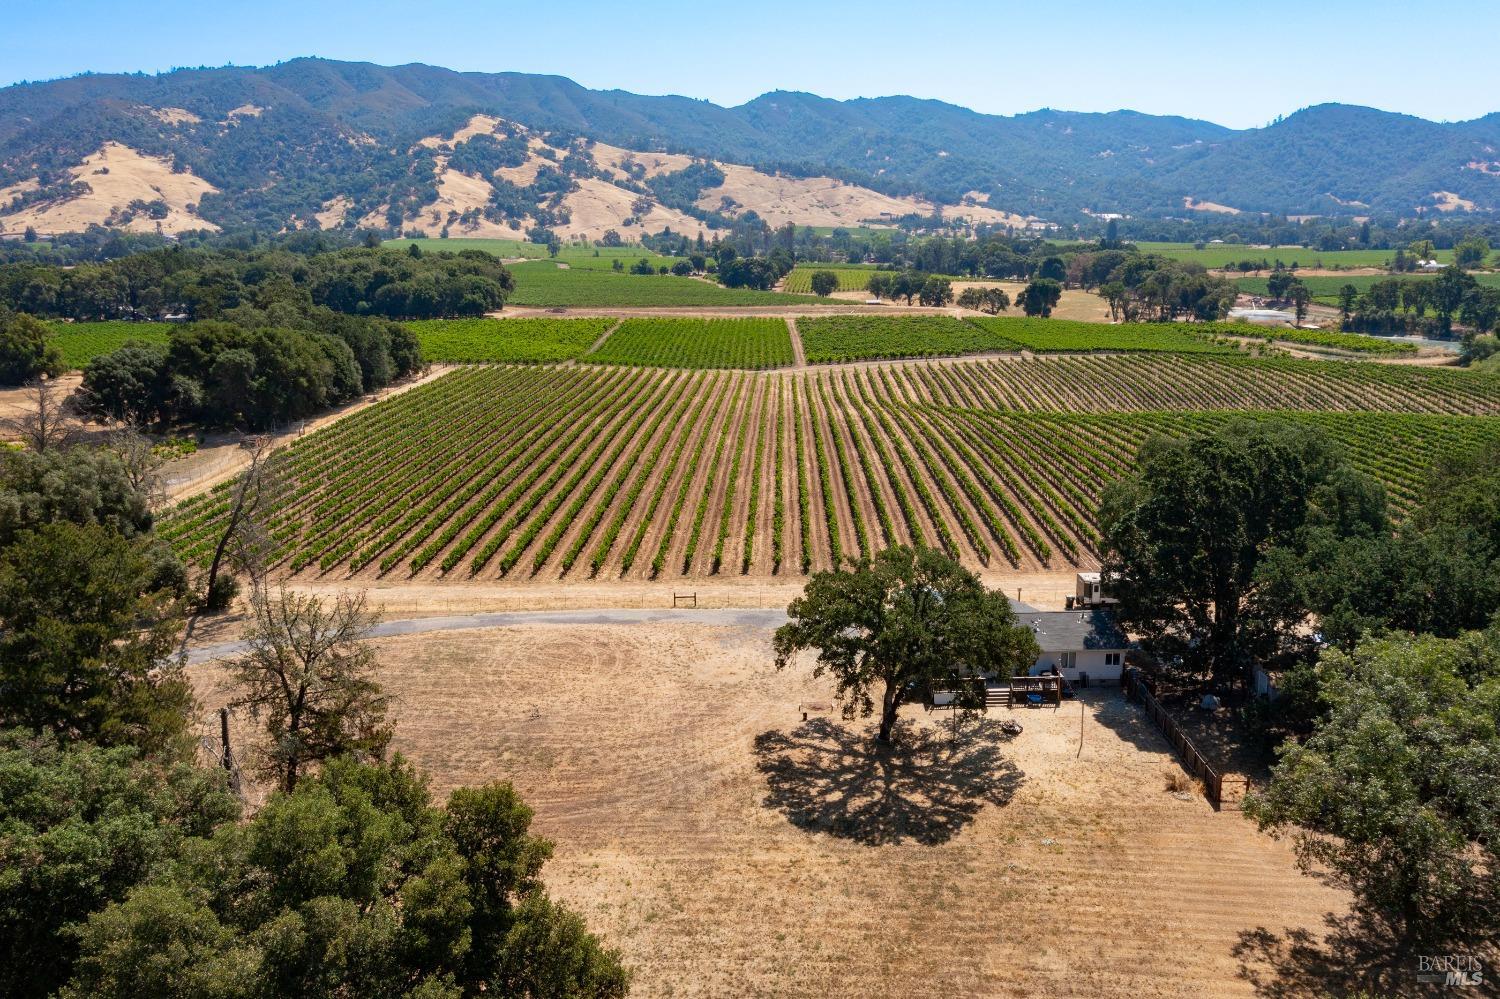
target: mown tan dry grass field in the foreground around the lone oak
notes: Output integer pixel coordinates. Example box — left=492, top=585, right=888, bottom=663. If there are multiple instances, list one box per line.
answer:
left=192, top=621, right=1343, bottom=996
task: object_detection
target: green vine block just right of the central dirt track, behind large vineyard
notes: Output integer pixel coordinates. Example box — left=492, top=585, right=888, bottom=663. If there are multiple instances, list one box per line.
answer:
left=797, top=315, right=1020, bottom=365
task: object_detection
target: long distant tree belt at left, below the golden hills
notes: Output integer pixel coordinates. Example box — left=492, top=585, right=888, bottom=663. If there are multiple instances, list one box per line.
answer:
left=0, top=240, right=515, bottom=320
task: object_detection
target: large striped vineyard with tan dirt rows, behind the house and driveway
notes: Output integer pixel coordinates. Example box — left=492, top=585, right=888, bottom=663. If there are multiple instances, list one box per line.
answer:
left=162, top=356, right=1500, bottom=581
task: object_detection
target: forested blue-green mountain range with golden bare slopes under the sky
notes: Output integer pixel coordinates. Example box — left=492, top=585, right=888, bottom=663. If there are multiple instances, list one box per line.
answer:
left=0, top=59, right=1500, bottom=234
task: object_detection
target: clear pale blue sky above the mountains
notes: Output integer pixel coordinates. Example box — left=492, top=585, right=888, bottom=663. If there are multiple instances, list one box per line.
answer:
left=0, top=0, right=1500, bottom=128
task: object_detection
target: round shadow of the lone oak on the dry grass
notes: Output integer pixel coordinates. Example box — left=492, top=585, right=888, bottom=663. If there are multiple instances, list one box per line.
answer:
left=755, top=719, right=1025, bottom=846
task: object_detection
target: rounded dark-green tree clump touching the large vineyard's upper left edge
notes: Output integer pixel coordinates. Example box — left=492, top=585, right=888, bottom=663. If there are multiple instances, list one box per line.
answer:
left=81, top=303, right=423, bottom=431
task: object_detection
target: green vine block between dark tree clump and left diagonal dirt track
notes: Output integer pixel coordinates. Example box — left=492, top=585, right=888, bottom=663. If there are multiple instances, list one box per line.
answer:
left=405, top=320, right=615, bottom=363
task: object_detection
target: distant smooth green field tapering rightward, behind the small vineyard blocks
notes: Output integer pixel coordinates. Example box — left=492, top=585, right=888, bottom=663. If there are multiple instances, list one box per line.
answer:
left=509, top=264, right=818, bottom=308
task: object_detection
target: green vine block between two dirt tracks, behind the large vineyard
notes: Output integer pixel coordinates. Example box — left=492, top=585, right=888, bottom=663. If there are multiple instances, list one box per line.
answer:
left=584, top=318, right=795, bottom=369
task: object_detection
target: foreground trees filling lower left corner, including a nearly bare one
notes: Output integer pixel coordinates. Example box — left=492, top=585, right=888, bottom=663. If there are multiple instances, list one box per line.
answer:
left=0, top=408, right=629, bottom=999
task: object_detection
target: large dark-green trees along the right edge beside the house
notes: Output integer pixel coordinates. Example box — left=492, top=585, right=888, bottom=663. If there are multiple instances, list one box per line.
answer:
left=1100, top=422, right=1500, bottom=945
